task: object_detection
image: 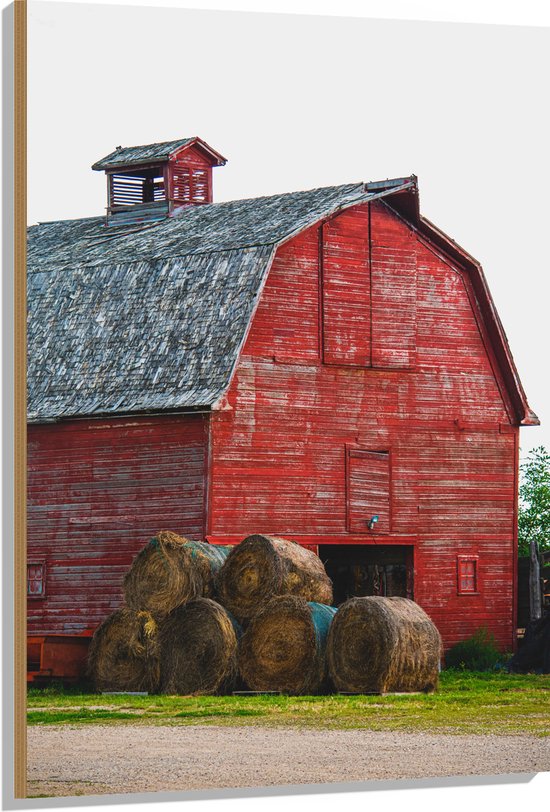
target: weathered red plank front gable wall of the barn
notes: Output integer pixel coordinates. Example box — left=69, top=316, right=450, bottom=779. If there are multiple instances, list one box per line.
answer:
left=208, top=202, right=518, bottom=646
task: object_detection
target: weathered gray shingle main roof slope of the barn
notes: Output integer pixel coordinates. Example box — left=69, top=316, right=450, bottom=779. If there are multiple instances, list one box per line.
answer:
left=28, top=184, right=406, bottom=422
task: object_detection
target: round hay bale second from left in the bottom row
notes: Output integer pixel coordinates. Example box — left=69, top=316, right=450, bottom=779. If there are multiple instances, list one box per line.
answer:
left=160, top=598, right=241, bottom=695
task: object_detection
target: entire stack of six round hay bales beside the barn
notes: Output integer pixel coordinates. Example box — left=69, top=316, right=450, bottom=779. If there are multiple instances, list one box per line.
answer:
left=89, top=531, right=441, bottom=695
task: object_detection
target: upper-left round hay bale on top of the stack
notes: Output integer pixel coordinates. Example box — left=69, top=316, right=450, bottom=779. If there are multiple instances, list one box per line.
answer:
left=123, top=530, right=233, bottom=616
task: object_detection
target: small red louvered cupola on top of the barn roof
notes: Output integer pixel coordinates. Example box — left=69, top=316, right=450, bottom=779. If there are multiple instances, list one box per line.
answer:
left=92, top=136, right=227, bottom=225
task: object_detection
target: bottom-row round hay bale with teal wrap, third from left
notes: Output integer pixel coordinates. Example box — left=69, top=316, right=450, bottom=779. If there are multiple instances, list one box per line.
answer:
left=239, top=595, right=337, bottom=694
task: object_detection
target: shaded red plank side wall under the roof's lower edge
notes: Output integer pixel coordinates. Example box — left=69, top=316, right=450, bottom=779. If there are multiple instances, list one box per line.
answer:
left=28, top=416, right=207, bottom=635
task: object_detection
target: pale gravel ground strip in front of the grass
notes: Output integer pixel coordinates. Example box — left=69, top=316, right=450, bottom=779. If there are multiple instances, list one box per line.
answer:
left=28, top=725, right=550, bottom=796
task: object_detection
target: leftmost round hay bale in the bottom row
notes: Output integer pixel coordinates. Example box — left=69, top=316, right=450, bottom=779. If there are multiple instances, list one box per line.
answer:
left=88, top=607, right=160, bottom=693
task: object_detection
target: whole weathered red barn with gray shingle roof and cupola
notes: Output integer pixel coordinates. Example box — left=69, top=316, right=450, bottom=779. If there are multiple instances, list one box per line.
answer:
left=28, top=138, right=538, bottom=674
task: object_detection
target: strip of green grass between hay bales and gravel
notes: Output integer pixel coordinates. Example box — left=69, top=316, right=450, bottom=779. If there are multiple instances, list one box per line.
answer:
left=28, top=671, right=550, bottom=736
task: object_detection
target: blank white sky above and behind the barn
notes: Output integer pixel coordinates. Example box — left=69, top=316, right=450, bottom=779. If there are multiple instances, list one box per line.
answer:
left=28, top=0, right=550, bottom=464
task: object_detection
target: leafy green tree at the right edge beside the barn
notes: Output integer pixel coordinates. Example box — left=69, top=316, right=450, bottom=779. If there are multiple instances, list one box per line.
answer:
left=518, top=445, right=550, bottom=555
